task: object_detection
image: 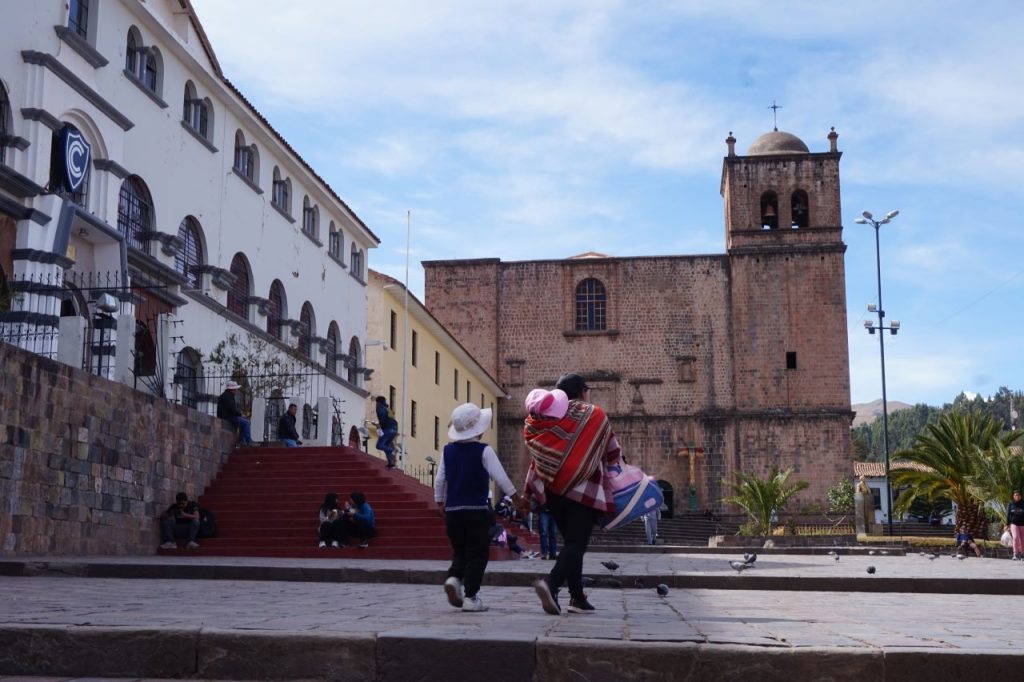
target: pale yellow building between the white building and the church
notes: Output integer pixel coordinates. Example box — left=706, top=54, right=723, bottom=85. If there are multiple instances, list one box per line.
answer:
left=366, top=270, right=505, bottom=482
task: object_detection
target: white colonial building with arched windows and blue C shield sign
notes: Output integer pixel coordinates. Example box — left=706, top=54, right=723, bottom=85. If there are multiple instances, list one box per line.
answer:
left=0, top=0, right=379, bottom=441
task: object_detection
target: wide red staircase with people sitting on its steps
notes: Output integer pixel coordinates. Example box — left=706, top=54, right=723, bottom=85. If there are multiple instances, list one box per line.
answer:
left=160, top=440, right=525, bottom=560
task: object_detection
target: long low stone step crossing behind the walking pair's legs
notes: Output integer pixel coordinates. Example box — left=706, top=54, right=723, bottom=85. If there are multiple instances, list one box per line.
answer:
left=0, top=560, right=1024, bottom=596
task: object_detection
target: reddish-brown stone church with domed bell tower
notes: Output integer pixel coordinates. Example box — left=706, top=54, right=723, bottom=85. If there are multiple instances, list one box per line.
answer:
left=423, top=129, right=853, bottom=514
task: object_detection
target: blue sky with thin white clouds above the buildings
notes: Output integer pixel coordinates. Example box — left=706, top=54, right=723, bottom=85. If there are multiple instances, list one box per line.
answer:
left=193, top=0, right=1024, bottom=406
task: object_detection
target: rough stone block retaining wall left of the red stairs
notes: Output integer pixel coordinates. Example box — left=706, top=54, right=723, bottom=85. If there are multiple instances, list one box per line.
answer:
left=0, top=343, right=234, bottom=556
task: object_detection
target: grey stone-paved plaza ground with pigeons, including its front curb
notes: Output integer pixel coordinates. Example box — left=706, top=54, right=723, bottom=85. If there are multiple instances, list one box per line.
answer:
left=0, top=553, right=1024, bottom=682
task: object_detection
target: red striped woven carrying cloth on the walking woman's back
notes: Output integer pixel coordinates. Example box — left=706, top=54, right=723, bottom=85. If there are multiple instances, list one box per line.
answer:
left=523, top=400, right=620, bottom=512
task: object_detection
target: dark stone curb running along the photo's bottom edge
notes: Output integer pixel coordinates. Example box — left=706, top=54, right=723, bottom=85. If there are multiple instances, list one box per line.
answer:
left=0, top=626, right=1024, bottom=682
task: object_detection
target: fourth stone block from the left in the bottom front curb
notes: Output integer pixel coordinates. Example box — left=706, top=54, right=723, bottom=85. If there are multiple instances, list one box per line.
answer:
left=534, top=639, right=696, bottom=682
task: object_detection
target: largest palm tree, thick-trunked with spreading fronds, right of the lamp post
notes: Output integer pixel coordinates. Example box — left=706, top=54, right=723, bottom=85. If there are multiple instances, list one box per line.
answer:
left=890, top=412, right=1021, bottom=538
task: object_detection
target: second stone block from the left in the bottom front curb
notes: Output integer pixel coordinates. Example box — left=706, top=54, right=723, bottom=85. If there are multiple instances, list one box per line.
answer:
left=197, top=630, right=374, bottom=682
